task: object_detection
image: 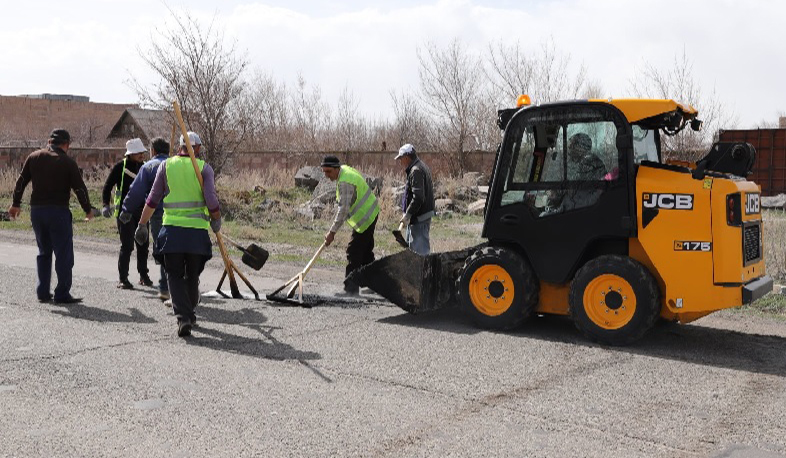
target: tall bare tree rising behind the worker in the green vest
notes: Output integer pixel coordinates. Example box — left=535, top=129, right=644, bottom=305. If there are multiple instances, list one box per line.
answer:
left=131, top=9, right=248, bottom=173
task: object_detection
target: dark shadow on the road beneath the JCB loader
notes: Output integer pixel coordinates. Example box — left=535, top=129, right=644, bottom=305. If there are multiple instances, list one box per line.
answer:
left=379, top=309, right=786, bottom=377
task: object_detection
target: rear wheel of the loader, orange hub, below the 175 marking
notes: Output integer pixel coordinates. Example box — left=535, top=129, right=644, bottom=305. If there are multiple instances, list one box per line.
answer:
left=570, top=255, right=660, bottom=345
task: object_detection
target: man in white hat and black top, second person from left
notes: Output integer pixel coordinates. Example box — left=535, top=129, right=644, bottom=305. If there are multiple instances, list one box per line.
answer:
left=101, top=138, right=153, bottom=289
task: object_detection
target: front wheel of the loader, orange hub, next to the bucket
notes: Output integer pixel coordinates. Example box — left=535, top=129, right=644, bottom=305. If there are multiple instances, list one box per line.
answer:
left=456, top=247, right=538, bottom=330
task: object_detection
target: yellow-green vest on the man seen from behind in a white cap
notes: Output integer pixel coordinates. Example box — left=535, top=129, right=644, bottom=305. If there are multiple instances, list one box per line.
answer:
left=163, top=156, right=210, bottom=229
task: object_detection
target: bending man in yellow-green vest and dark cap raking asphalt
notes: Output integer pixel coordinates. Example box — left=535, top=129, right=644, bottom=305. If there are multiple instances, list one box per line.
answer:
left=321, top=156, right=379, bottom=296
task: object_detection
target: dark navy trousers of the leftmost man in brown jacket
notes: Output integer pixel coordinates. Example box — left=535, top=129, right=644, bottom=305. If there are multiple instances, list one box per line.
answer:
left=30, top=205, right=74, bottom=300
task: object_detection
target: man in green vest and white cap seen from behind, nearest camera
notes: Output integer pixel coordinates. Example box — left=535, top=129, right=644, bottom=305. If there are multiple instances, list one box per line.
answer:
left=135, top=132, right=221, bottom=337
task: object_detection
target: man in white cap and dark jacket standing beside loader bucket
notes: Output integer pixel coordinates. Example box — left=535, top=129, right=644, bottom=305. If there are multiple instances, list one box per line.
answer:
left=395, top=143, right=434, bottom=256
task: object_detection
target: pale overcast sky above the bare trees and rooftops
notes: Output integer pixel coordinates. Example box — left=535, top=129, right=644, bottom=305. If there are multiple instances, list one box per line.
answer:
left=0, top=0, right=786, bottom=128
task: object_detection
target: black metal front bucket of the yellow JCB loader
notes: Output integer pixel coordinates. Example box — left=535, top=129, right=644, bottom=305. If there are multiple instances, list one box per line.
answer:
left=350, top=247, right=477, bottom=313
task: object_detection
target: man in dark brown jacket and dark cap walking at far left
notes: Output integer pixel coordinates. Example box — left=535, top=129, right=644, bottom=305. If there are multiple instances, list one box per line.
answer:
left=8, top=129, right=93, bottom=304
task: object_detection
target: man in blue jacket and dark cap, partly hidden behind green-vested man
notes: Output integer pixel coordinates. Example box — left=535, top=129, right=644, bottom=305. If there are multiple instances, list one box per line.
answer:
left=119, top=137, right=169, bottom=301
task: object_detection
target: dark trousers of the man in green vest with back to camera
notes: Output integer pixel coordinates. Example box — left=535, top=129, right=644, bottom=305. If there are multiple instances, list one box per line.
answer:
left=164, top=253, right=207, bottom=323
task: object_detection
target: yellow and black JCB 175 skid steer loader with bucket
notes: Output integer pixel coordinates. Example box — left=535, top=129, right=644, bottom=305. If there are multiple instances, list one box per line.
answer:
left=354, top=96, right=773, bottom=345
